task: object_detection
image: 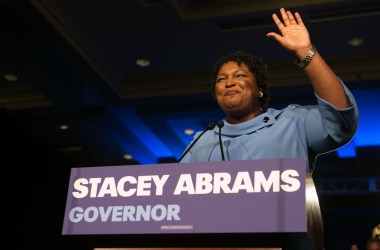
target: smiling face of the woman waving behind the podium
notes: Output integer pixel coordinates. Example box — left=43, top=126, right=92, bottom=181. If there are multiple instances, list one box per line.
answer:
left=215, top=61, right=261, bottom=119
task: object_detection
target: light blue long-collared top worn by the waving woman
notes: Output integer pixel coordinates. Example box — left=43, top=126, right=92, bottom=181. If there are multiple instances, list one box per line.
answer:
left=181, top=84, right=359, bottom=170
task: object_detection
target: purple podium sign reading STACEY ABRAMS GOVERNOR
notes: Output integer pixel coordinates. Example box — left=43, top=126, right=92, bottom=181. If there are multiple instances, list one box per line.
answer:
left=62, top=158, right=306, bottom=235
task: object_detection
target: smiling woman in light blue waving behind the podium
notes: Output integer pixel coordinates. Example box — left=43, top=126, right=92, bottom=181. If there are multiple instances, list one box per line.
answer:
left=180, top=8, right=358, bottom=250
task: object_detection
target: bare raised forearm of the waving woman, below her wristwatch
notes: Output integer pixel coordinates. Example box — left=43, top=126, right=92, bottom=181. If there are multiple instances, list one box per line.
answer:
left=296, top=47, right=351, bottom=109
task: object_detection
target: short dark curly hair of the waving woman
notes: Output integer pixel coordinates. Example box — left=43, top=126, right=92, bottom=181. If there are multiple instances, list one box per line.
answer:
left=211, top=50, right=270, bottom=109
